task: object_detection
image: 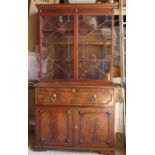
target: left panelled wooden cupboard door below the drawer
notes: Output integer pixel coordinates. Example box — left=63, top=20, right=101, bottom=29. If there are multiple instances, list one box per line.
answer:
left=36, top=107, right=72, bottom=146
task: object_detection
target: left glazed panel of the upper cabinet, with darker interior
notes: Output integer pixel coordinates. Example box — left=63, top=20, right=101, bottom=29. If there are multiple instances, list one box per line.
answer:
left=41, top=16, right=73, bottom=79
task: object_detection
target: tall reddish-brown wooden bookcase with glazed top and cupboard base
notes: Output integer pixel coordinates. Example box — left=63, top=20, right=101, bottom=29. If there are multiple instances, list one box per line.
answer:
left=35, top=3, right=117, bottom=155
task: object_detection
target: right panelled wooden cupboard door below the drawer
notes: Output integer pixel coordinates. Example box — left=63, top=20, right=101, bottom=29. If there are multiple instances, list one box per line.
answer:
left=74, top=108, right=114, bottom=148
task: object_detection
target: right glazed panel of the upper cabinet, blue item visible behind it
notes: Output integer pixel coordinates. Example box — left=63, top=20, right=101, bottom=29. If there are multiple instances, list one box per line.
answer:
left=78, top=16, right=112, bottom=80
